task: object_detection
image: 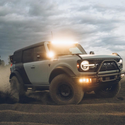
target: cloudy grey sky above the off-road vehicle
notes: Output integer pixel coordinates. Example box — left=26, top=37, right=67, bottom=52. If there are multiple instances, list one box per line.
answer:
left=0, top=0, right=125, bottom=63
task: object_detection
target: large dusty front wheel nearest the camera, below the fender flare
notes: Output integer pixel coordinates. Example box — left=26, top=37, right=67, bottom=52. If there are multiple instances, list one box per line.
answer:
left=50, top=74, right=84, bottom=104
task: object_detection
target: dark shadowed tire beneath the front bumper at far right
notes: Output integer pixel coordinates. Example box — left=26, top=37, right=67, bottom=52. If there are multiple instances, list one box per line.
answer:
left=95, top=82, right=121, bottom=98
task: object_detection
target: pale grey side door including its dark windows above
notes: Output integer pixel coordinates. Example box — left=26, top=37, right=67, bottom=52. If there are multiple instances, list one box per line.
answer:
left=23, top=45, right=49, bottom=86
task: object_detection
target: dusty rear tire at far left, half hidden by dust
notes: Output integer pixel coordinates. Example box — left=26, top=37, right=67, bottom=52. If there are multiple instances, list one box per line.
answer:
left=10, top=76, right=25, bottom=102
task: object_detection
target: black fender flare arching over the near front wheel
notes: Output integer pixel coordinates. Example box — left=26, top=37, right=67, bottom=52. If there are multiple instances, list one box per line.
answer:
left=49, top=66, right=76, bottom=83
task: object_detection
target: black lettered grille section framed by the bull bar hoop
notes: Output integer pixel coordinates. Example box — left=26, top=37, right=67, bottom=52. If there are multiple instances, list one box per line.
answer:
left=100, top=61, right=118, bottom=71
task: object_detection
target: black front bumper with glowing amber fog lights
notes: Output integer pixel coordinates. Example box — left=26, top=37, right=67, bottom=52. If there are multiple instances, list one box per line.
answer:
left=73, top=72, right=125, bottom=91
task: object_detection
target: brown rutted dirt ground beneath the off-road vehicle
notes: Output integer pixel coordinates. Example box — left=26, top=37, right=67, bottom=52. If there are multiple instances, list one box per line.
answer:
left=0, top=78, right=125, bottom=125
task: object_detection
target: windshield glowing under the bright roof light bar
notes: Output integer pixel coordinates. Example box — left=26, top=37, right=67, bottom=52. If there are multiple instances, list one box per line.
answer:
left=48, top=44, right=86, bottom=55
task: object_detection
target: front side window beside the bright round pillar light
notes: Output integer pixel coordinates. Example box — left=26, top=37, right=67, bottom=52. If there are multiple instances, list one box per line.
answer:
left=33, top=45, right=46, bottom=61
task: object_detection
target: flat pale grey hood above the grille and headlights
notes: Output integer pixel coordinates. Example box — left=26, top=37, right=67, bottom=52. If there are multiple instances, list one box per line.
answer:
left=79, top=54, right=121, bottom=59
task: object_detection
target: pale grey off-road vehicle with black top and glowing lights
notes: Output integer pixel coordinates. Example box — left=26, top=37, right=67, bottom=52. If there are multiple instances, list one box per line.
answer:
left=10, top=41, right=123, bottom=104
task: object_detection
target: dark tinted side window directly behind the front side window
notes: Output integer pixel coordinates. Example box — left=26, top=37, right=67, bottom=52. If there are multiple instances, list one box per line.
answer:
left=23, top=48, right=34, bottom=63
